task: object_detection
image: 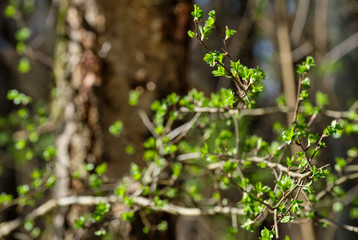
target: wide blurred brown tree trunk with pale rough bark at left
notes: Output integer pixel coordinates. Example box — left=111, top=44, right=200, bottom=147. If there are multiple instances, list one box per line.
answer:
left=51, top=0, right=192, bottom=239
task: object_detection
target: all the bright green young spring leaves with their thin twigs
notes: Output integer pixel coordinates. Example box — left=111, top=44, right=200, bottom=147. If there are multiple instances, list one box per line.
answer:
left=0, top=3, right=358, bottom=240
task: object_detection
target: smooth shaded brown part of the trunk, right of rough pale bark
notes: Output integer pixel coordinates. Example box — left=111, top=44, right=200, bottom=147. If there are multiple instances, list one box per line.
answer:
left=99, top=0, right=192, bottom=178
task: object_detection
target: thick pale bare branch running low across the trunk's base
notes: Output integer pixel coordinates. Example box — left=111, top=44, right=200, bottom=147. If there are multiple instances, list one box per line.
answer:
left=0, top=195, right=244, bottom=239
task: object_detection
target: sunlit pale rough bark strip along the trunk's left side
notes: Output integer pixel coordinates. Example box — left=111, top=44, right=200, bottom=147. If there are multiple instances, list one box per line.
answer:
left=52, top=0, right=104, bottom=239
